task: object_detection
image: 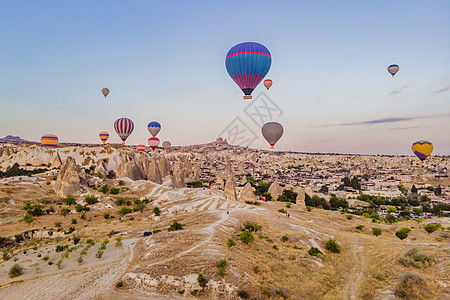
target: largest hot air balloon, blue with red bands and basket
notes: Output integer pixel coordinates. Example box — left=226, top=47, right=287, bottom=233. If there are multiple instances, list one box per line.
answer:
left=225, top=42, right=272, bottom=99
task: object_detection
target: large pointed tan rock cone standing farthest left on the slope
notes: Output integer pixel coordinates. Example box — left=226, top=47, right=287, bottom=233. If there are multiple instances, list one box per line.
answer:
left=53, top=156, right=86, bottom=197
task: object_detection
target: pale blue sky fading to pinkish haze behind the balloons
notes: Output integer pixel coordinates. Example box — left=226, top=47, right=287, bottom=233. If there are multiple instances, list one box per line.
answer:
left=0, top=0, right=450, bottom=154
